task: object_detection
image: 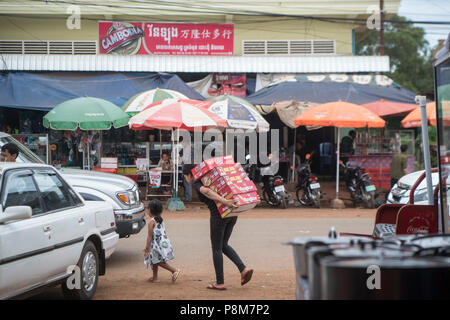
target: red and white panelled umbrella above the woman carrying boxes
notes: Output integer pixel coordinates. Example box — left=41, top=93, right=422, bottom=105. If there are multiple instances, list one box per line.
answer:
left=129, top=99, right=228, bottom=130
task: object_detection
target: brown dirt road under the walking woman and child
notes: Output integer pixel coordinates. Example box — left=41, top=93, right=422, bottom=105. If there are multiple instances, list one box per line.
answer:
left=35, top=204, right=375, bottom=300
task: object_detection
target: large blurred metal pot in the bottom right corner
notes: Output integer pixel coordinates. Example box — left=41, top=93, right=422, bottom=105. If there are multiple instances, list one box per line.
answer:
left=320, top=256, right=450, bottom=300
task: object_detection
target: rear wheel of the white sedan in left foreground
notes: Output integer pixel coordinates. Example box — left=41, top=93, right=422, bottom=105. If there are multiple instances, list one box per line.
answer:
left=62, top=241, right=100, bottom=300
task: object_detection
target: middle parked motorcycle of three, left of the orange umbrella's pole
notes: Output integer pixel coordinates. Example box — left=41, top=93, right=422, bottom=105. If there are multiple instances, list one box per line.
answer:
left=295, top=154, right=324, bottom=208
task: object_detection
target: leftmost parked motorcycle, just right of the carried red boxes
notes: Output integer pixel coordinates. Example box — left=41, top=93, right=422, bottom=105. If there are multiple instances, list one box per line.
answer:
left=244, top=155, right=290, bottom=209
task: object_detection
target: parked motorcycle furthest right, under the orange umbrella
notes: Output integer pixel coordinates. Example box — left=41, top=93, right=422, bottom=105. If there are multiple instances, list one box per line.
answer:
left=340, top=162, right=376, bottom=209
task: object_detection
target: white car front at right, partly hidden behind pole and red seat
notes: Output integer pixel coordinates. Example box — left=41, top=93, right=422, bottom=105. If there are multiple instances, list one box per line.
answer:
left=387, top=170, right=439, bottom=205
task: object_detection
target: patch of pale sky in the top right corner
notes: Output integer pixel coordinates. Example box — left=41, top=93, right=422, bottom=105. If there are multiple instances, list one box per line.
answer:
left=398, top=0, right=450, bottom=48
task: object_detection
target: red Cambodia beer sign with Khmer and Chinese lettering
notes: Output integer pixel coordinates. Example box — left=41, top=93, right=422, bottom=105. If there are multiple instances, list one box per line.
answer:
left=99, top=21, right=234, bottom=55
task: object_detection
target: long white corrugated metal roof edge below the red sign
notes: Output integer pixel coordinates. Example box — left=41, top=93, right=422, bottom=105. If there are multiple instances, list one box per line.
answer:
left=0, top=54, right=389, bottom=73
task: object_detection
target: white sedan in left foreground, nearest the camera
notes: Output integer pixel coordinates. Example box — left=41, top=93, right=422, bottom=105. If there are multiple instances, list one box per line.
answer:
left=0, top=162, right=119, bottom=299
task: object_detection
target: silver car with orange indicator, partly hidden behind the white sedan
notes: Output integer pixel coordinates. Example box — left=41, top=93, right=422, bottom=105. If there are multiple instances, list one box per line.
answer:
left=0, top=132, right=145, bottom=238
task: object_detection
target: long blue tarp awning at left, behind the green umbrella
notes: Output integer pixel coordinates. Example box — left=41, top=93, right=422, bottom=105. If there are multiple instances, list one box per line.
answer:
left=0, top=72, right=204, bottom=111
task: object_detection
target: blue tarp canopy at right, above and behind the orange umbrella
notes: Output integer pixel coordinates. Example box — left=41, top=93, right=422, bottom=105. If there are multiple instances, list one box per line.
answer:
left=247, top=75, right=416, bottom=106
